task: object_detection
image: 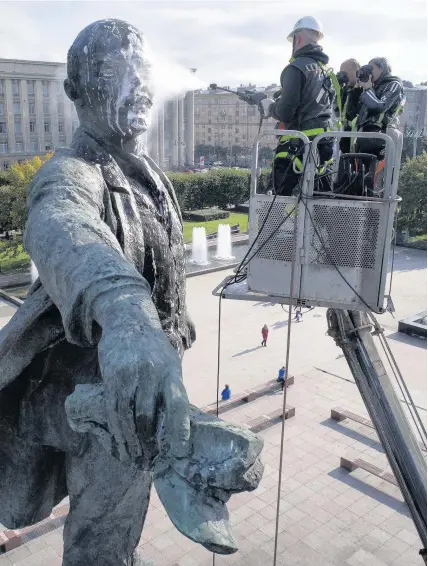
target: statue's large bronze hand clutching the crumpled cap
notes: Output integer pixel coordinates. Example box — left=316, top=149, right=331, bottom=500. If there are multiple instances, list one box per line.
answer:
left=98, top=311, right=190, bottom=469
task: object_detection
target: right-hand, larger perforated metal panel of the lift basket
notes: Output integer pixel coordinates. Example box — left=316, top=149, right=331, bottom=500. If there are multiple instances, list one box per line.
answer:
left=309, top=204, right=380, bottom=269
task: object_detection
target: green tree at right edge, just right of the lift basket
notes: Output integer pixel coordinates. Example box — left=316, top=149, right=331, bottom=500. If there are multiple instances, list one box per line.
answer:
left=398, top=153, right=427, bottom=234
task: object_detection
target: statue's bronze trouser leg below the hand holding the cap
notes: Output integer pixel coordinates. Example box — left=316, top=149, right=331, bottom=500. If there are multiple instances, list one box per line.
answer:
left=63, top=438, right=152, bottom=566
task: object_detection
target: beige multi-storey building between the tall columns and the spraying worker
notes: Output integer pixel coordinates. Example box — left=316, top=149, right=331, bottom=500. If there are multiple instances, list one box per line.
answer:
left=195, top=85, right=279, bottom=152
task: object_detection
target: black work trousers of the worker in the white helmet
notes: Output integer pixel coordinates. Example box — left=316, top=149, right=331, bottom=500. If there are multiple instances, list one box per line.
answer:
left=270, top=138, right=333, bottom=196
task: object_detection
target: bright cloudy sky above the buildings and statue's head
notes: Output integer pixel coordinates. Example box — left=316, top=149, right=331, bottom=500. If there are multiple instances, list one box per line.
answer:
left=0, top=0, right=427, bottom=90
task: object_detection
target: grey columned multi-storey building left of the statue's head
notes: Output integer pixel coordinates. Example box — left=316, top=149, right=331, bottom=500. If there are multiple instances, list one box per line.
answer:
left=0, top=59, right=78, bottom=170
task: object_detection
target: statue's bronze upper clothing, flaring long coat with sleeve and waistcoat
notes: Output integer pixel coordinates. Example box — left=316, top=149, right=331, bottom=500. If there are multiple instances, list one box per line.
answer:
left=0, top=130, right=194, bottom=528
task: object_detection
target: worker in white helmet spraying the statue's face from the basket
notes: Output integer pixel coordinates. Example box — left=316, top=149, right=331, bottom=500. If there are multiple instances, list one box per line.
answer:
left=260, top=16, right=339, bottom=195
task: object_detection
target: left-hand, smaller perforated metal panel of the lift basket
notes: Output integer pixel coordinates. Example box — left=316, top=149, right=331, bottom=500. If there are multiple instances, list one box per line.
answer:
left=255, top=201, right=297, bottom=262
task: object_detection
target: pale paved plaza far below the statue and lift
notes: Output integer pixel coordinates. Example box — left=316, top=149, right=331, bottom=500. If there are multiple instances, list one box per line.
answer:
left=0, top=248, right=427, bottom=566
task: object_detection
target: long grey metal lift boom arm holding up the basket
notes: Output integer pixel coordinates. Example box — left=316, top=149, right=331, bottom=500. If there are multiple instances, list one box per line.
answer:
left=327, top=308, right=427, bottom=563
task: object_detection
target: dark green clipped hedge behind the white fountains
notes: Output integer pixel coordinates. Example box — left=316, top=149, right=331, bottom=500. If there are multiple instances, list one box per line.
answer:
left=167, top=169, right=269, bottom=211
